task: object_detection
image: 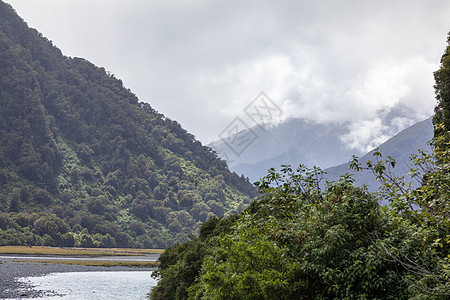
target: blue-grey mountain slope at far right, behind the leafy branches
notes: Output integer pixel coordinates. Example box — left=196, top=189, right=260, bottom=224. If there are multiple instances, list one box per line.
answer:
left=325, top=117, right=433, bottom=191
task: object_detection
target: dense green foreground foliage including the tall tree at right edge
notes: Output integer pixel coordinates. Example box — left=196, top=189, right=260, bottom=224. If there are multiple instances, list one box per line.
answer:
left=151, top=34, right=450, bottom=299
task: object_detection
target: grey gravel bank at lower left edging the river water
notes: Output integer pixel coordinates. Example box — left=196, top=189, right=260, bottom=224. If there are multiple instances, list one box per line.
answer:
left=0, top=261, right=155, bottom=299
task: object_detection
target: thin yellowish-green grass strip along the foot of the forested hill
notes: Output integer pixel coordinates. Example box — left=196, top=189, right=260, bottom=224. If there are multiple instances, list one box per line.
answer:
left=0, top=246, right=164, bottom=257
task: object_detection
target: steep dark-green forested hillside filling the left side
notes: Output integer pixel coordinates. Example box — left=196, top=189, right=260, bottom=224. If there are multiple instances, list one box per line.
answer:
left=0, top=2, right=255, bottom=248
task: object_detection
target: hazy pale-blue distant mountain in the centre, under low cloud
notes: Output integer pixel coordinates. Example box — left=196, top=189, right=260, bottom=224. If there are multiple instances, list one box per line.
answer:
left=210, top=119, right=363, bottom=182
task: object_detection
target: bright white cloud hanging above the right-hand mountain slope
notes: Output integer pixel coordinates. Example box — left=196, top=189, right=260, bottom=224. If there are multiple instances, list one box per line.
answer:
left=342, top=57, right=434, bottom=152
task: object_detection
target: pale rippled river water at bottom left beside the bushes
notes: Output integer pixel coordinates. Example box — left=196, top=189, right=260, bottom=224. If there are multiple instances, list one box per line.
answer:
left=17, top=271, right=157, bottom=299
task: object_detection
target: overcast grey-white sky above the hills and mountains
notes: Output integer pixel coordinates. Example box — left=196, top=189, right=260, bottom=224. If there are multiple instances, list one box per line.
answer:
left=6, top=0, right=450, bottom=152
